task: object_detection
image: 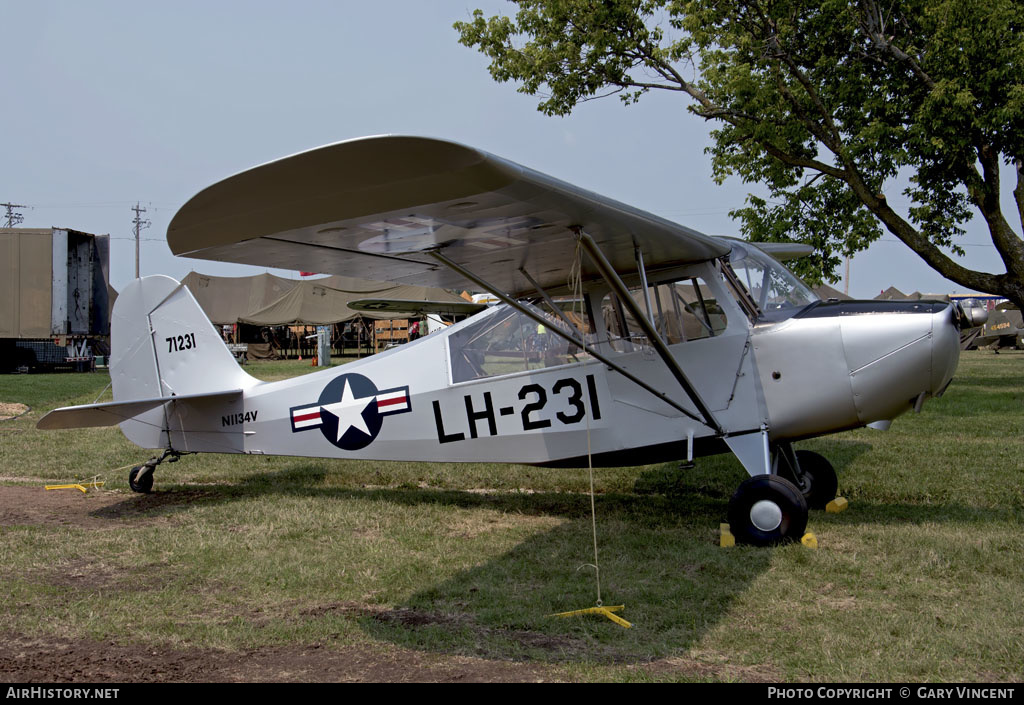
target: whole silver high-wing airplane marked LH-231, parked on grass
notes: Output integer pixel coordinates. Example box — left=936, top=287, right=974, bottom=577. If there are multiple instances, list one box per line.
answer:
left=38, top=135, right=964, bottom=545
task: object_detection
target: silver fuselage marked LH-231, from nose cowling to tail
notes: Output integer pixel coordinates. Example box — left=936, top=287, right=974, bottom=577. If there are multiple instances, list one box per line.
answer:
left=116, top=251, right=959, bottom=474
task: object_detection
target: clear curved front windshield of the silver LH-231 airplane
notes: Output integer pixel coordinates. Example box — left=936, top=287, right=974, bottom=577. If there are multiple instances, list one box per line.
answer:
left=729, top=243, right=821, bottom=321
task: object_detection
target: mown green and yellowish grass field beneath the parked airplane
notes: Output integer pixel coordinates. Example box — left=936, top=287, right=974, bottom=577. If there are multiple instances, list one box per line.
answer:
left=0, top=351, right=1024, bottom=681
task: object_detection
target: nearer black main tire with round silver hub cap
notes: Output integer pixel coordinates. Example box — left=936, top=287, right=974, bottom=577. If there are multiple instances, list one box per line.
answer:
left=729, top=474, right=807, bottom=546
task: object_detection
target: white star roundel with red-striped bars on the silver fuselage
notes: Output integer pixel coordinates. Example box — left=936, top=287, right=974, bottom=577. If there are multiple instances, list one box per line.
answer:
left=291, top=373, right=413, bottom=451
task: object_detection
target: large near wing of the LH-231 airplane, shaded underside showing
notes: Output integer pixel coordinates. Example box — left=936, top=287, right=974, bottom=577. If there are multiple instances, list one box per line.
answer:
left=167, top=135, right=728, bottom=295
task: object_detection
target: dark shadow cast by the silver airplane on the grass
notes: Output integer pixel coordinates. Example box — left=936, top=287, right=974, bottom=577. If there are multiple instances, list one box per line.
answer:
left=83, top=442, right=1011, bottom=664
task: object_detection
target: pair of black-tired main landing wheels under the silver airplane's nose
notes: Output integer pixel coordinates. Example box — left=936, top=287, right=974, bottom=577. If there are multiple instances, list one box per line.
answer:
left=729, top=443, right=839, bottom=546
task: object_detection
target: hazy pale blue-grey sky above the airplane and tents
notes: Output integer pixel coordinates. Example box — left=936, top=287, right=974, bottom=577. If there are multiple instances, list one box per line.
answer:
left=0, top=0, right=1005, bottom=298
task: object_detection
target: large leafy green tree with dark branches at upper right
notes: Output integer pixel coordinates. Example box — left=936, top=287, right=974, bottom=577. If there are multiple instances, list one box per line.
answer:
left=455, top=0, right=1024, bottom=304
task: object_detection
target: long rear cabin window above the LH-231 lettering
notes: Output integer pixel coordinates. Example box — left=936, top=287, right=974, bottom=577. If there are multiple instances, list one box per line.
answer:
left=449, top=302, right=593, bottom=382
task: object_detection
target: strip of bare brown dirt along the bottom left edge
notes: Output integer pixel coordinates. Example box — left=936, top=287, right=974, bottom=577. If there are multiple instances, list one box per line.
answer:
left=0, top=635, right=559, bottom=682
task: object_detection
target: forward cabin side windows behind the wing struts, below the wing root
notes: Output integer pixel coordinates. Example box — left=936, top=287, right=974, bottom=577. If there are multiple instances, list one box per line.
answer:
left=601, top=277, right=726, bottom=353
